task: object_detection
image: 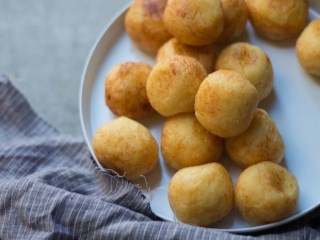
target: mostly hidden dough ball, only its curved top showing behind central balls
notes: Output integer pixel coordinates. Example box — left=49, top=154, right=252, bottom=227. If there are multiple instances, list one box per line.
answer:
left=157, top=38, right=216, bottom=73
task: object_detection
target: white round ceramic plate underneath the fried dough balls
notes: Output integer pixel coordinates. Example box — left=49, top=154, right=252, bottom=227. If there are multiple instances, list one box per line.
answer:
left=80, top=0, right=320, bottom=233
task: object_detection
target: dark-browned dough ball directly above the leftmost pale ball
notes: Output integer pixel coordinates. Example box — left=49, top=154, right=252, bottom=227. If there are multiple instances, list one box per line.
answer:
left=105, top=62, right=152, bottom=119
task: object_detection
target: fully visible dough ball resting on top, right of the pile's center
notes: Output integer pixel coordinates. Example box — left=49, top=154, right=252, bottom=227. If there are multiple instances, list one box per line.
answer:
left=195, top=70, right=258, bottom=138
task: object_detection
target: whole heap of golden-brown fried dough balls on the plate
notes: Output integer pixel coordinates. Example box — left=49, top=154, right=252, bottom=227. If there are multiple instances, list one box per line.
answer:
left=93, top=0, right=320, bottom=226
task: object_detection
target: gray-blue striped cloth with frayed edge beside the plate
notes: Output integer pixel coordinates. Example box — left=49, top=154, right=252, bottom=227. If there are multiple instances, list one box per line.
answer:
left=0, top=76, right=320, bottom=240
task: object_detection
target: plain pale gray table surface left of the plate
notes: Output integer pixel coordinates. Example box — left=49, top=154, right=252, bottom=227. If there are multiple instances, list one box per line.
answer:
left=0, top=0, right=130, bottom=138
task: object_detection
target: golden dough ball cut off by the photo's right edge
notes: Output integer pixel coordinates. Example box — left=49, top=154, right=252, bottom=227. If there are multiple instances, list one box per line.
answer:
left=296, top=19, right=320, bottom=76
